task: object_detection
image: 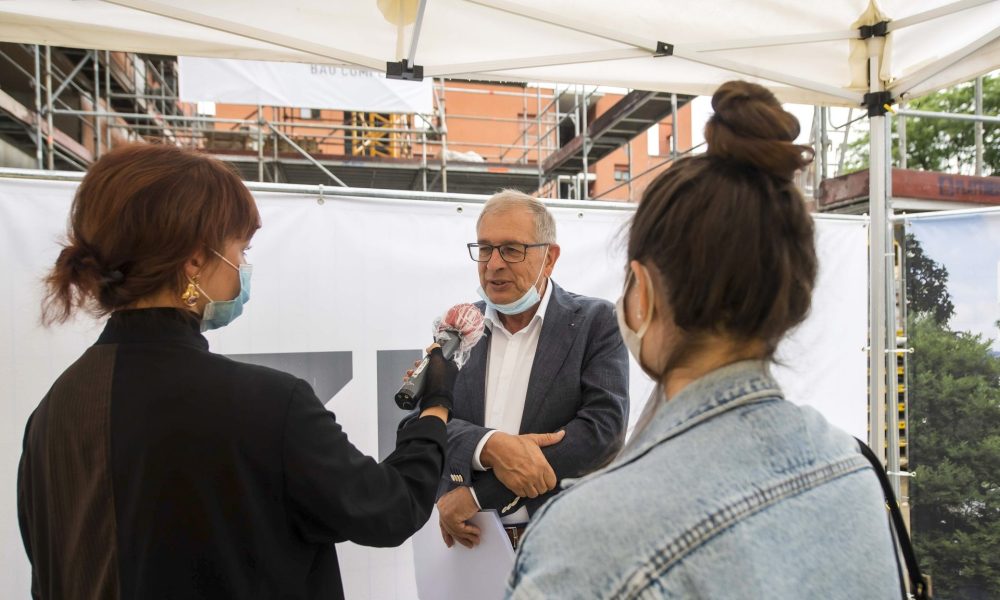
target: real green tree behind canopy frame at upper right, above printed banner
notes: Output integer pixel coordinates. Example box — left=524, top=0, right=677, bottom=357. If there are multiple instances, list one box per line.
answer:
left=845, top=74, right=1000, bottom=175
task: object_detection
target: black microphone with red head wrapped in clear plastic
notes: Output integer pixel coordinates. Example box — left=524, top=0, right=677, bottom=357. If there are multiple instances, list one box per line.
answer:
left=396, top=304, right=486, bottom=410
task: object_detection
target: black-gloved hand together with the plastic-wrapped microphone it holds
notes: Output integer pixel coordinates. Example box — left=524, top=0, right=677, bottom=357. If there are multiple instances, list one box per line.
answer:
left=396, top=304, right=485, bottom=410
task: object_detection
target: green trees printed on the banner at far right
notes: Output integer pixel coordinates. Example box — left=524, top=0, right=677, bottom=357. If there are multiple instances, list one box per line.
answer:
left=907, top=252, right=1000, bottom=599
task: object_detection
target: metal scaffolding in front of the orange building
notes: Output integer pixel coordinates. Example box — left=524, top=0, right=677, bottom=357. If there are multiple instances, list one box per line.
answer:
left=0, top=44, right=696, bottom=199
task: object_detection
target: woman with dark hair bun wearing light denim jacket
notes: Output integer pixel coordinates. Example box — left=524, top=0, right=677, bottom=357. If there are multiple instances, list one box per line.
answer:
left=508, top=81, right=902, bottom=599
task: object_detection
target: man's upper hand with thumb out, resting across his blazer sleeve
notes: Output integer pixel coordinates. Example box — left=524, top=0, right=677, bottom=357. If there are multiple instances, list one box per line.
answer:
left=479, top=430, right=566, bottom=498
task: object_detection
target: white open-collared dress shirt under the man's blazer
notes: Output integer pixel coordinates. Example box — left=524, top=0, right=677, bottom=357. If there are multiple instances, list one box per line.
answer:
left=470, top=281, right=552, bottom=524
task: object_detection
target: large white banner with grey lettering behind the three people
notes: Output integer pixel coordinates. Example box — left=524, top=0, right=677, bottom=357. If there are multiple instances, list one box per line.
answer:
left=0, top=179, right=867, bottom=599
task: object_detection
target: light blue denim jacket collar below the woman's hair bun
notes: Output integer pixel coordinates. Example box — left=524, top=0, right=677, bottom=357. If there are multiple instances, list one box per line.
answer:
left=615, top=360, right=783, bottom=463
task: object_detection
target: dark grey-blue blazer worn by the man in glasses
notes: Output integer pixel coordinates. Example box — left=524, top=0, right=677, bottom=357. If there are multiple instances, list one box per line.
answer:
left=438, top=280, right=628, bottom=515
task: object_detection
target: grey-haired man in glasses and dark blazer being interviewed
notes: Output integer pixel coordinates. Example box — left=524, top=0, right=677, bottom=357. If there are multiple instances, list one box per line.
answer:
left=430, top=190, right=628, bottom=547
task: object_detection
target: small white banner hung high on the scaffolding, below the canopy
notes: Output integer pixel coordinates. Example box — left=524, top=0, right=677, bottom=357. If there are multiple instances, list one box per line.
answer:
left=178, top=56, right=434, bottom=114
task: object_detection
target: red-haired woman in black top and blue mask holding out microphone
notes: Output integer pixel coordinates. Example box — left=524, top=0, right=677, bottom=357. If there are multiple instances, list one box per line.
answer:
left=17, top=145, right=457, bottom=600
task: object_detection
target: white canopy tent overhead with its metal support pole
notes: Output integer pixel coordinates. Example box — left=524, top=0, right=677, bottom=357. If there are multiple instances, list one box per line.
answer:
left=0, top=0, right=1000, bottom=488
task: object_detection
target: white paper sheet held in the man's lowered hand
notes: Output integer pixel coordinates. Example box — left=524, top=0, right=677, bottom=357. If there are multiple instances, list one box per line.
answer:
left=413, top=507, right=514, bottom=600
